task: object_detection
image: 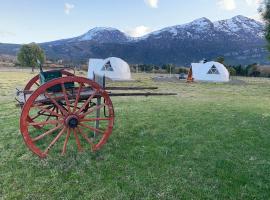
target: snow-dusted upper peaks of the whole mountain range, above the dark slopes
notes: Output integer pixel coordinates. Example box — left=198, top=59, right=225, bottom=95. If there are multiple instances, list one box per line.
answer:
left=61, top=15, right=264, bottom=43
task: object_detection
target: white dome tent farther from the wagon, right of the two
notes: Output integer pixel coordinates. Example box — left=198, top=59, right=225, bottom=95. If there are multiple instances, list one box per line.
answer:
left=188, top=61, right=230, bottom=82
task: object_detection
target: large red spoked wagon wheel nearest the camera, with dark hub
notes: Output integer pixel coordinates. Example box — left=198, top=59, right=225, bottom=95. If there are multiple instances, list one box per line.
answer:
left=20, top=76, right=114, bottom=158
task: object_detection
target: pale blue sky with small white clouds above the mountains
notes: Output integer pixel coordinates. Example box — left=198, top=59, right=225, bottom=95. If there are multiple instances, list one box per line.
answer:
left=0, top=0, right=260, bottom=43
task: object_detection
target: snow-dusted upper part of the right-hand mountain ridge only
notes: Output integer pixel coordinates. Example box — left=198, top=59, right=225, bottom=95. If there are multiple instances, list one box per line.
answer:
left=141, top=15, right=264, bottom=40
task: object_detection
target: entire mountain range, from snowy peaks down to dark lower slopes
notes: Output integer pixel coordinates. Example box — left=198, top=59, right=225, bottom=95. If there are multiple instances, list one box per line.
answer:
left=0, top=15, right=269, bottom=65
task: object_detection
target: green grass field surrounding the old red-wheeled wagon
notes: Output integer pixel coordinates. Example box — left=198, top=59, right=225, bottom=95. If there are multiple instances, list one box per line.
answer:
left=0, top=72, right=270, bottom=200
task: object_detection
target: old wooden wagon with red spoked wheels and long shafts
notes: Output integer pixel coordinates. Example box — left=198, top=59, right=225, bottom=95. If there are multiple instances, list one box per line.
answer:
left=16, top=70, right=175, bottom=158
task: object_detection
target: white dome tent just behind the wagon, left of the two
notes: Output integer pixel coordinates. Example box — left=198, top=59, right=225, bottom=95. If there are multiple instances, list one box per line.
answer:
left=88, top=57, right=131, bottom=81
